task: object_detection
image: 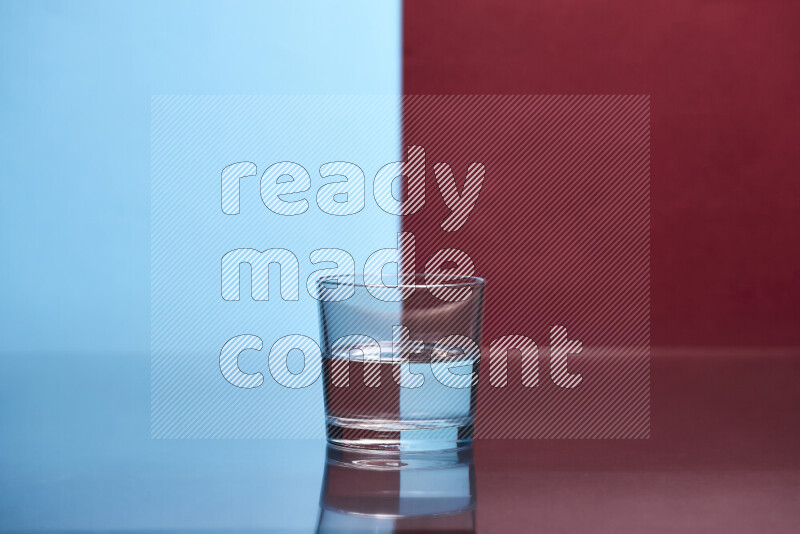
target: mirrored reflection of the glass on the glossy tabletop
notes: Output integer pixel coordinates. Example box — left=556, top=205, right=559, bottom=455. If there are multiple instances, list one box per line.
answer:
left=317, top=446, right=476, bottom=534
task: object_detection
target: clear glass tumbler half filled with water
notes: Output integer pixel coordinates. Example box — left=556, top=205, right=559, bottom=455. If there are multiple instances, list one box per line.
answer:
left=318, top=274, right=484, bottom=451
